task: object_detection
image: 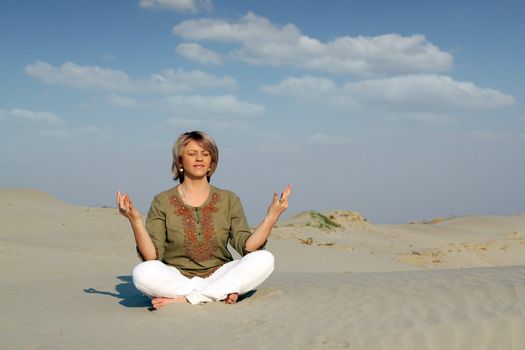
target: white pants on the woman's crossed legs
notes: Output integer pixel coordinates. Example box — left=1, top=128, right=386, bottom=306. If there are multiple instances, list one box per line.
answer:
left=133, top=250, right=274, bottom=304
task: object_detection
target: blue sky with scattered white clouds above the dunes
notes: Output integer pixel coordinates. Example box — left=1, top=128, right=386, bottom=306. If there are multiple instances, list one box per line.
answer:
left=0, top=0, right=525, bottom=224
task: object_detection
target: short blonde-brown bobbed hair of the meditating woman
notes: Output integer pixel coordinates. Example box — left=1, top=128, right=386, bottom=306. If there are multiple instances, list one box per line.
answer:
left=171, top=131, right=219, bottom=183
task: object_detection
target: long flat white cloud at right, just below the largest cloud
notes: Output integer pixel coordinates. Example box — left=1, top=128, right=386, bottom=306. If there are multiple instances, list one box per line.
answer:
left=262, top=75, right=516, bottom=113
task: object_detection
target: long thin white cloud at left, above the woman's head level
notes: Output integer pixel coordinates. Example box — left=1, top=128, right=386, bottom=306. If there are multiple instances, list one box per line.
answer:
left=25, top=61, right=236, bottom=94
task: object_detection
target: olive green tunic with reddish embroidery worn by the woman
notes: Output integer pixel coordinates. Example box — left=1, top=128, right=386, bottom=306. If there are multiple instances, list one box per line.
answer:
left=141, top=185, right=251, bottom=277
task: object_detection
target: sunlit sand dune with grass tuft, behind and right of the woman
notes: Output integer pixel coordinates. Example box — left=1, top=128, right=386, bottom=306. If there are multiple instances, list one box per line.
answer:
left=273, top=210, right=525, bottom=272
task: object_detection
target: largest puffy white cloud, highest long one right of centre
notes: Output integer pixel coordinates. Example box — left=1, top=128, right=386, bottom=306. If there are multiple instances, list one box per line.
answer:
left=173, top=13, right=453, bottom=76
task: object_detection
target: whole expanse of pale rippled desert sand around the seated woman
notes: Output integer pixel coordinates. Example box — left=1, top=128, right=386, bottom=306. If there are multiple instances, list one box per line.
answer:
left=0, top=188, right=525, bottom=350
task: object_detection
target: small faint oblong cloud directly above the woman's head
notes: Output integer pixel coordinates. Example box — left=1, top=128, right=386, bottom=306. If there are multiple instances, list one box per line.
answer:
left=166, top=95, right=264, bottom=119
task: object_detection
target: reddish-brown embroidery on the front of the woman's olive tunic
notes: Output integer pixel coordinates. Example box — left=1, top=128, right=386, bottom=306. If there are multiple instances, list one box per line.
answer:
left=170, top=193, right=221, bottom=262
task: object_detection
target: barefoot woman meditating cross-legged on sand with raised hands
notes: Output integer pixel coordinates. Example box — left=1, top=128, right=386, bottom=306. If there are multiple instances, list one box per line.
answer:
left=117, top=131, right=291, bottom=309
